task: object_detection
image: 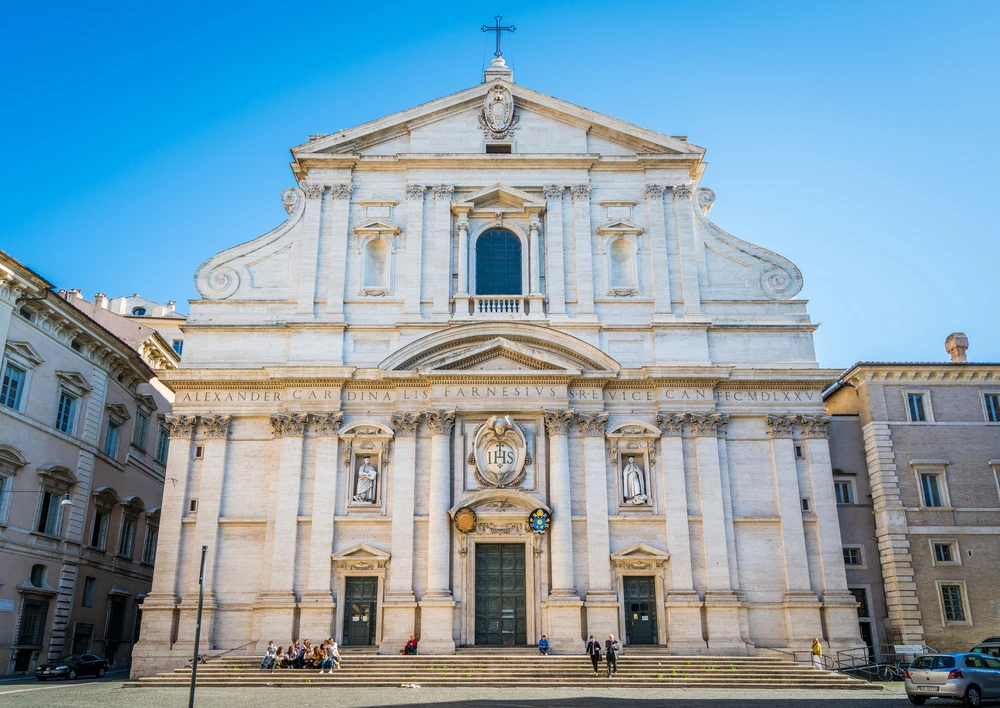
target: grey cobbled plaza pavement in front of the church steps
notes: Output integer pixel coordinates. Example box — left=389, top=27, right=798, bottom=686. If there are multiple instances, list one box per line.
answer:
left=0, top=679, right=924, bottom=708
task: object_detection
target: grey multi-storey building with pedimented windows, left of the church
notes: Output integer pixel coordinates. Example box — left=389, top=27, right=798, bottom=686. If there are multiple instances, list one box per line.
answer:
left=0, top=252, right=179, bottom=674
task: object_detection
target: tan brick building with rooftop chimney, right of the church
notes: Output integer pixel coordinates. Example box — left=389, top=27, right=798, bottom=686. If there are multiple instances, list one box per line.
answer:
left=825, top=334, right=1000, bottom=651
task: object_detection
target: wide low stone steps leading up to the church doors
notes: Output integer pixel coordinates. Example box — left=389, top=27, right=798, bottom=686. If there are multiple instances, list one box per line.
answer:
left=125, top=647, right=882, bottom=690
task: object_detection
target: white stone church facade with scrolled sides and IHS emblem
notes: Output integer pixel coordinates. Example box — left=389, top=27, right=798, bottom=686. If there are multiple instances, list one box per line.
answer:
left=133, top=59, right=859, bottom=675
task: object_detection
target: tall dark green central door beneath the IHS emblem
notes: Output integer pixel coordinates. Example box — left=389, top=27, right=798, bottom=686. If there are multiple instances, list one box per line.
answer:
left=476, top=543, right=528, bottom=646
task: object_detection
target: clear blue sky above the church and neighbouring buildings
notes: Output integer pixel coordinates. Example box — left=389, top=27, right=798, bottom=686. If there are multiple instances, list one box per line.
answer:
left=0, top=0, right=1000, bottom=366
